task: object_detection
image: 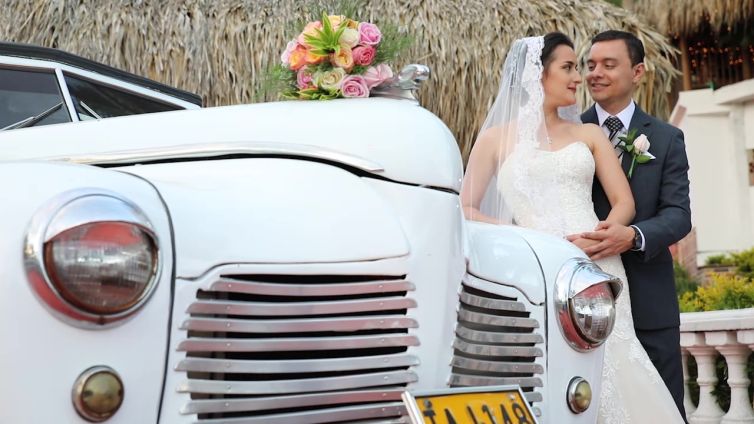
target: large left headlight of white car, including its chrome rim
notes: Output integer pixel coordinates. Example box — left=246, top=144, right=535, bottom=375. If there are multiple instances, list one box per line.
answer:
left=24, top=190, right=160, bottom=326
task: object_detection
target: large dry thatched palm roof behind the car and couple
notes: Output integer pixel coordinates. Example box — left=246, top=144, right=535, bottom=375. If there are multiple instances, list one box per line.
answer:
left=0, top=0, right=676, bottom=159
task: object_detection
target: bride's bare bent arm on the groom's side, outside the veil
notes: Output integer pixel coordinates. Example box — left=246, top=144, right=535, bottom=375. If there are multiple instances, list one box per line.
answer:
left=585, top=124, right=636, bottom=226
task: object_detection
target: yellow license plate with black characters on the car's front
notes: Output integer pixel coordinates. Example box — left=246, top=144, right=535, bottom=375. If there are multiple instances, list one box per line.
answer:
left=403, top=386, right=537, bottom=424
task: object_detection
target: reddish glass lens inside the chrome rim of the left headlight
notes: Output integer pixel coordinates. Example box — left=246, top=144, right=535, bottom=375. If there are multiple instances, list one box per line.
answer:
left=44, top=222, right=157, bottom=315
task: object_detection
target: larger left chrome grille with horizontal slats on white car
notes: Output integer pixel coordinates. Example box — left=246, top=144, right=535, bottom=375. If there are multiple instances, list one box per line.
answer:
left=176, top=275, right=419, bottom=424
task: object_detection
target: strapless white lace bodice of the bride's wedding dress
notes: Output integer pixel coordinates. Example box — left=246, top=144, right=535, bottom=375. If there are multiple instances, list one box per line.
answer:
left=498, top=141, right=598, bottom=236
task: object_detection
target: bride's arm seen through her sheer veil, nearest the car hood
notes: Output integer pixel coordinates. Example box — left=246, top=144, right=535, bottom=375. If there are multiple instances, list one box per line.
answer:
left=461, top=128, right=501, bottom=224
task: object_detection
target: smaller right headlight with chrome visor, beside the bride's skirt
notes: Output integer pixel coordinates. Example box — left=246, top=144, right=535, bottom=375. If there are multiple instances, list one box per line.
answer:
left=554, top=258, right=622, bottom=352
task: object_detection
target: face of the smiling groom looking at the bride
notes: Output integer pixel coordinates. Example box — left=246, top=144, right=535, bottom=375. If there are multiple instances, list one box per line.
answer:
left=586, top=40, right=643, bottom=106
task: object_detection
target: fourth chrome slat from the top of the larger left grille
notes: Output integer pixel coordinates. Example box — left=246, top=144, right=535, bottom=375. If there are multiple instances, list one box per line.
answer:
left=177, top=334, right=419, bottom=352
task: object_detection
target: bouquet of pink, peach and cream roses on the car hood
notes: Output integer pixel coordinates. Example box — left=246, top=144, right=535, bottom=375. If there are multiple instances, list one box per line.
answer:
left=276, top=13, right=407, bottom=100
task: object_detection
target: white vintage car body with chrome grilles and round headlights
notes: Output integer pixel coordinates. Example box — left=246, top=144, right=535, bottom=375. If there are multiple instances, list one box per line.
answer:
left=0, top=51, right=620, bottom=424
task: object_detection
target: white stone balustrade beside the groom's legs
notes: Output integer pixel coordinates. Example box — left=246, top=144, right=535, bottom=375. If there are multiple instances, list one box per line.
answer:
left=681, top=308, right=754, bottom=424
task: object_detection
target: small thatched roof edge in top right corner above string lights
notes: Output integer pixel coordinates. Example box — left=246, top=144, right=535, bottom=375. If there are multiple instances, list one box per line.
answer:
left=632, top=0, right=754, bottom=36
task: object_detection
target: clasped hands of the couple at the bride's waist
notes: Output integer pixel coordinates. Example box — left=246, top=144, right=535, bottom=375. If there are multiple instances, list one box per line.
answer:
left=566, top=221, right=634, bottom=260
